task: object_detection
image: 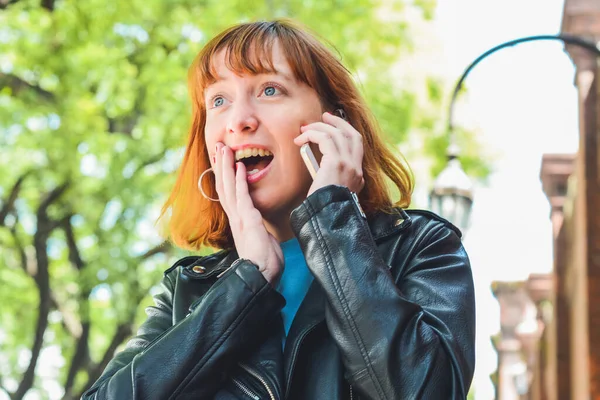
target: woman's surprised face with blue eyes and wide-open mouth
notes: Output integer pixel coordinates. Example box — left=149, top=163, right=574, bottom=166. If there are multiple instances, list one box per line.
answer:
left=204, top=43, right=323, bottom=220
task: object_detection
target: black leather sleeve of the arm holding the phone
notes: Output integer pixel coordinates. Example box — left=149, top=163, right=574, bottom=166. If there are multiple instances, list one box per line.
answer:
left=291, top=186, right=475, bottom=400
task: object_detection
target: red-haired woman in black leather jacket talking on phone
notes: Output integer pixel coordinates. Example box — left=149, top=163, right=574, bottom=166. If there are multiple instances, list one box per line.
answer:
left=83, top=21, right=475, bottom=400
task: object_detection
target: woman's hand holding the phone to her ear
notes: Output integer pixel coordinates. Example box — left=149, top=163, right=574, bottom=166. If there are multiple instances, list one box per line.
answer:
left=294, top=112, right=365, bottom=195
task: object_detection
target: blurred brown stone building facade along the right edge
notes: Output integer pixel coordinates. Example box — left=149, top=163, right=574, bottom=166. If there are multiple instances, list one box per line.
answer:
left=492, top=0, right=600, bottom=400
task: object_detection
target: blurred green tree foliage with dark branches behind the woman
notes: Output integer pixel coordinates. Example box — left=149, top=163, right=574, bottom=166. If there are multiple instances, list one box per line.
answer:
left=0, top=0, right=481, bottom=400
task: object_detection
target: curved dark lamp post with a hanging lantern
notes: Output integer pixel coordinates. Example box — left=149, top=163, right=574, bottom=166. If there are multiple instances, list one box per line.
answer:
left=429, top=35, right=600, bottom=232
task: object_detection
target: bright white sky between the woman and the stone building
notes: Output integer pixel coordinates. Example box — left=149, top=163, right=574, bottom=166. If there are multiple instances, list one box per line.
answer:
left=435, top=0, right=578, bottom=400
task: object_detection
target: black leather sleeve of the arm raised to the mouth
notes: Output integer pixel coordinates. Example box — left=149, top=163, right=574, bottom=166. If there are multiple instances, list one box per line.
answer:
left=82, top=261, right=284, bottom=400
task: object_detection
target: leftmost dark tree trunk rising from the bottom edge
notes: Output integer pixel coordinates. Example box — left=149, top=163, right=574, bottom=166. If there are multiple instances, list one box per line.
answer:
left=11, top=183, right=68, bottom=400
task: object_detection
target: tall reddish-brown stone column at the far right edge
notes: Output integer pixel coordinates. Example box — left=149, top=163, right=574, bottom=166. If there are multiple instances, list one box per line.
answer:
left=562, top=0, right=600, bottom=400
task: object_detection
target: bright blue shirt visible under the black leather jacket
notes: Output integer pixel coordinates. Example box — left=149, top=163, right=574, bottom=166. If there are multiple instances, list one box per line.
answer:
left=277, top=238, right=313, bottom=343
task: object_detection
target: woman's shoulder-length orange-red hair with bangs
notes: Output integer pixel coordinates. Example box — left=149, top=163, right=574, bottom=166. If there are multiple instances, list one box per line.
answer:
left=160, top=20, right=413, bottom=250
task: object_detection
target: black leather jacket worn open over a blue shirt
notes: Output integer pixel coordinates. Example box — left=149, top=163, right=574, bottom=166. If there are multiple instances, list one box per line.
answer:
left=83, top=186, right=475, bottom=400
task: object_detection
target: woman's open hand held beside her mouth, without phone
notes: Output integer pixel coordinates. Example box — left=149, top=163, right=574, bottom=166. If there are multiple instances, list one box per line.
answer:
left=213, top=143, right=284, bottom=285
